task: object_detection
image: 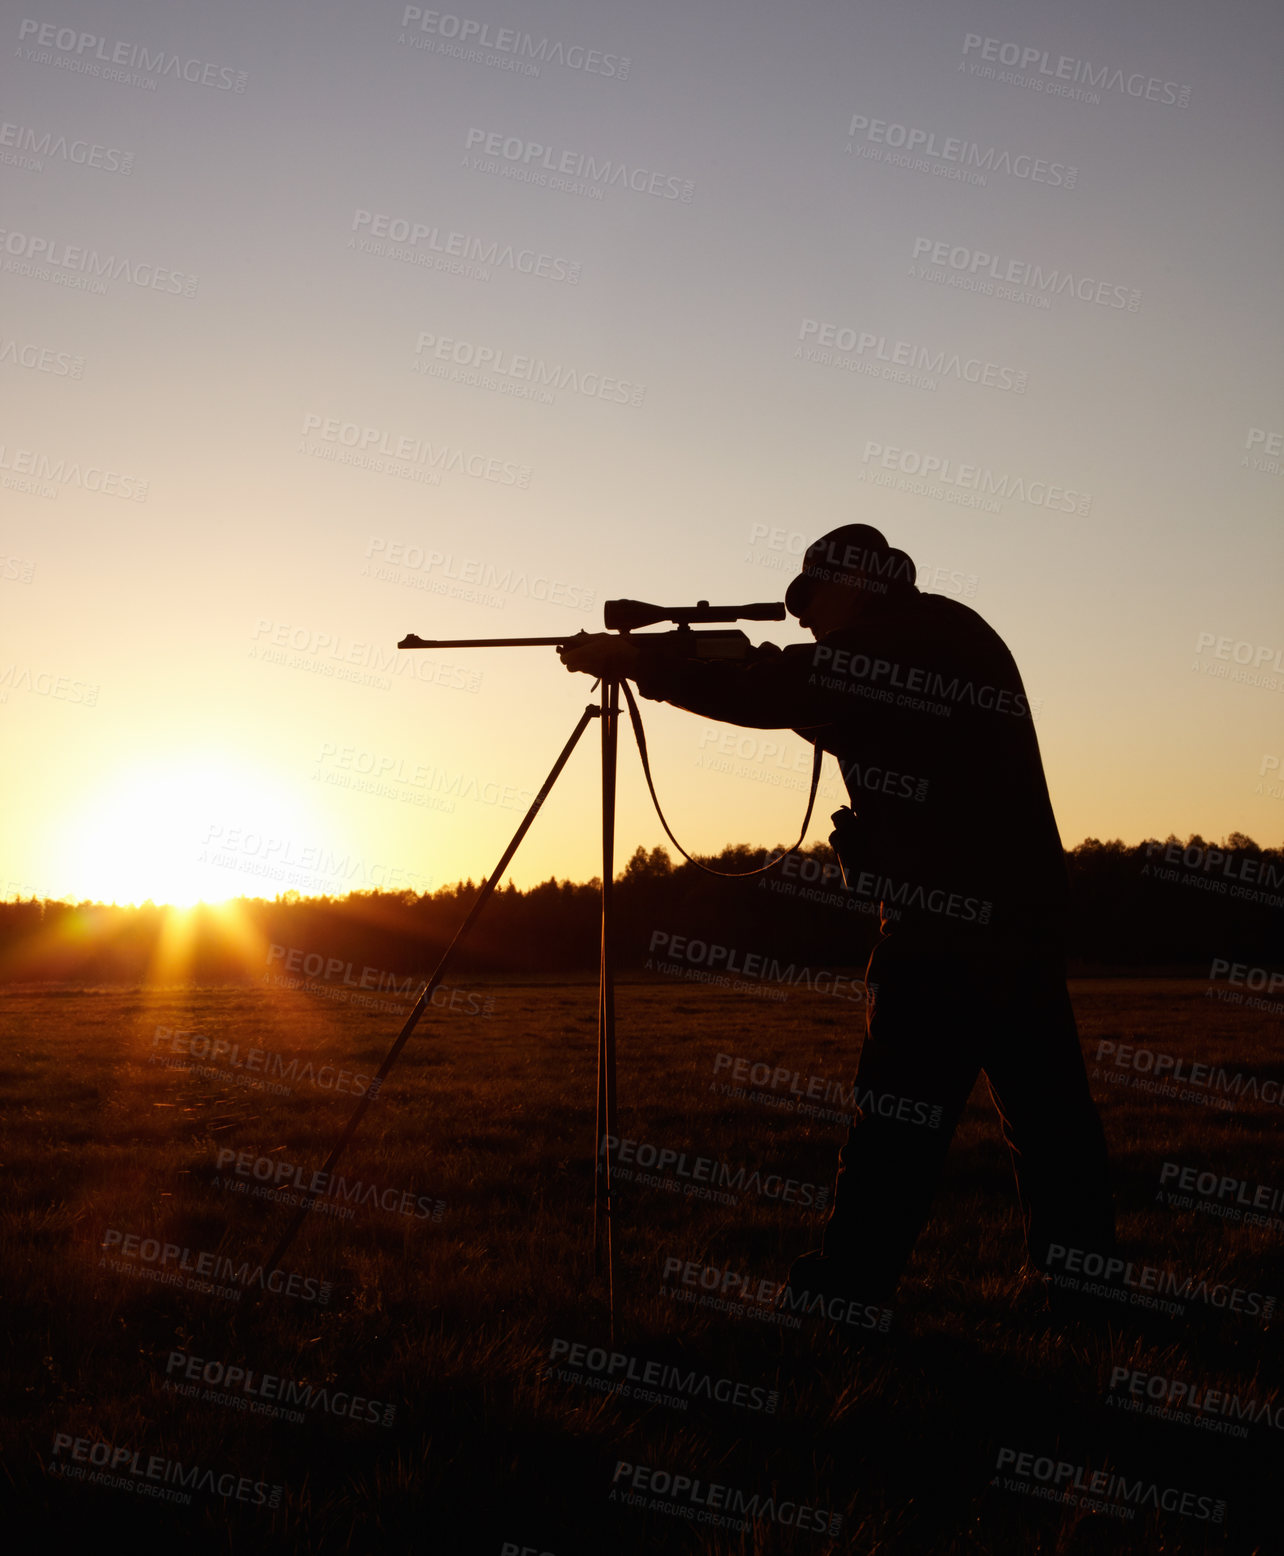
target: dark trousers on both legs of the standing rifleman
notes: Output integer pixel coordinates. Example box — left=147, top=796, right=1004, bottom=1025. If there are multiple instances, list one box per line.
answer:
left=823, top=930, right=1114, bottom=1299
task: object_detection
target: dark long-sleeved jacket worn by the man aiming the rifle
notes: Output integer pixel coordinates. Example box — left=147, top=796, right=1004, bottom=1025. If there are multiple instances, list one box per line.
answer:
left=635, top=588, right=1068, bottom=940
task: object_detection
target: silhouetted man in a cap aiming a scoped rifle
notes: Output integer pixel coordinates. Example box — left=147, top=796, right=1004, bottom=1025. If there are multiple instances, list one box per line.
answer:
left=562, top=524, right=1114, bottom=1319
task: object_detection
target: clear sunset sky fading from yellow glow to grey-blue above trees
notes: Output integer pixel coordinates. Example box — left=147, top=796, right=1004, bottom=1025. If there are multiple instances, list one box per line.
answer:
left=0, top=0, right=1284, bottom=901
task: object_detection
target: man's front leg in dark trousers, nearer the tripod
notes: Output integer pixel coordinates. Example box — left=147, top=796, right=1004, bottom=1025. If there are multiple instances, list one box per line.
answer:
left=823, top=937, right=984, bottom=1301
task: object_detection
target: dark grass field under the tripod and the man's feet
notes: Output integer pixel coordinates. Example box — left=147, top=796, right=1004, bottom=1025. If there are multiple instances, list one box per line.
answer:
left=0, top=979, right=1284, bottom=1556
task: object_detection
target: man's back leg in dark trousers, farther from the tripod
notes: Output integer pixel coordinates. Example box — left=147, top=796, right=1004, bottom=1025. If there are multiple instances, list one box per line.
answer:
left=982, top=957, right=1114, bottom=1274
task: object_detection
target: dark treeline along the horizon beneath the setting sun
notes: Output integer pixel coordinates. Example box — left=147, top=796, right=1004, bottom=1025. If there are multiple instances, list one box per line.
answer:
left=0, top=834, right=1284, bottom=987
